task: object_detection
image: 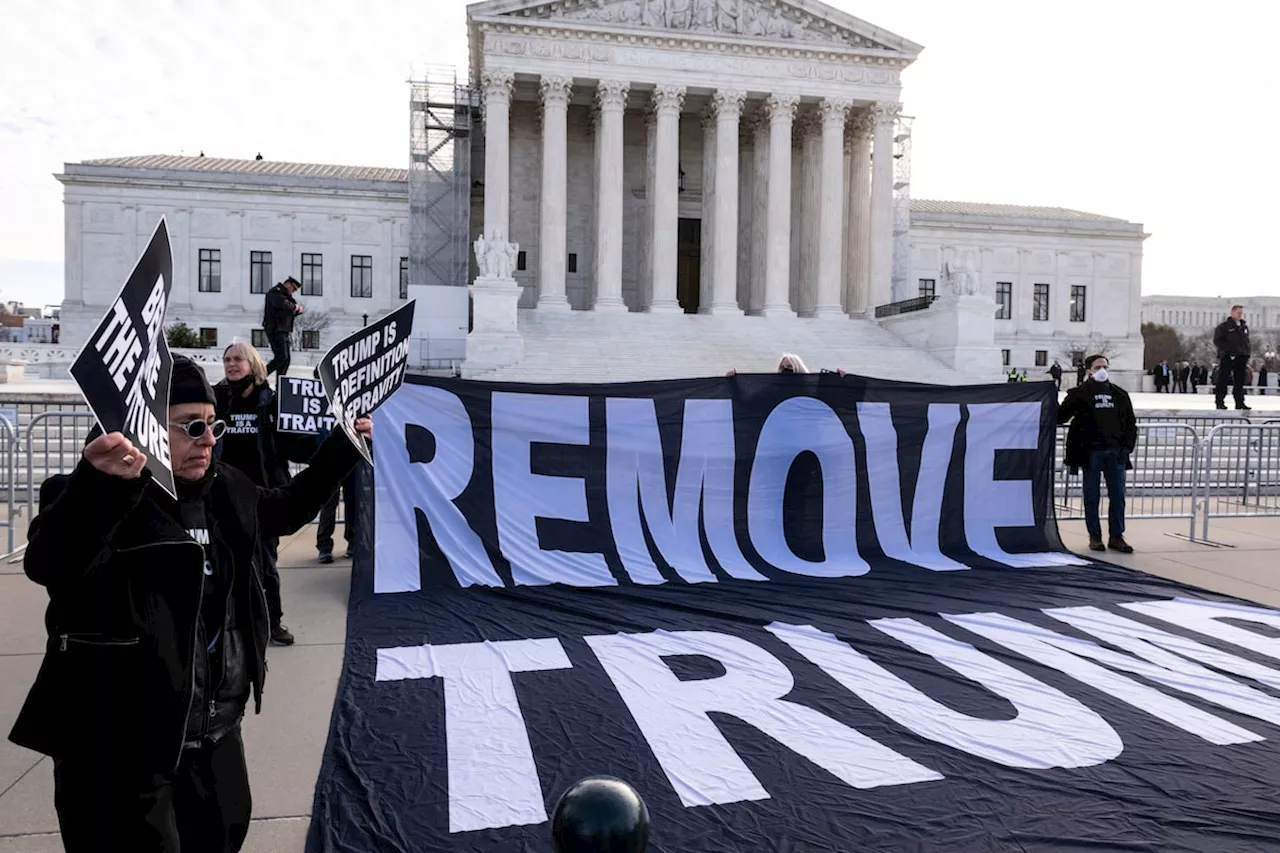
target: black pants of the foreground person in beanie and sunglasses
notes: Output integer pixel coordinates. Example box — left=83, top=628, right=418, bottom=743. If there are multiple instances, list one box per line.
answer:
left=54, top=727, right=252, bottom=853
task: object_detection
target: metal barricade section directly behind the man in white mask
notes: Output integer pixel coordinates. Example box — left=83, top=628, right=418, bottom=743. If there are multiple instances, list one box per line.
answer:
left=1053, top=421, right=1201, bottom=538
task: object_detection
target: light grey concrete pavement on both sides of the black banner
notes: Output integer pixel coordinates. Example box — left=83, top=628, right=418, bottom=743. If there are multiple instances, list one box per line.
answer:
left=0, top=519, right=1280, bottom=853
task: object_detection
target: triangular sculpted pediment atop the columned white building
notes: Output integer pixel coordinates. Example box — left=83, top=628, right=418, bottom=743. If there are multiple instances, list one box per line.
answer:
left=467, top=0, right=923, bottom=59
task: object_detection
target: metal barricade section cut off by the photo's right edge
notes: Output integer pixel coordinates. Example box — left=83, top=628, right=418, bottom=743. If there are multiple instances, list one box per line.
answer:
left=1193, top=423, right=1280, bottom=544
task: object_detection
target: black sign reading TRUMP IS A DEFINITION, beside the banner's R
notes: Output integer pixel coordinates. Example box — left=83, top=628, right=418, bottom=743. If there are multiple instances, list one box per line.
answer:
left=320, top=300, right=415, bottom=465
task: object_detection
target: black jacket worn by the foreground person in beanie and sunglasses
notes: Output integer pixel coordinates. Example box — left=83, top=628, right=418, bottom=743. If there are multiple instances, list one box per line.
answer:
left=9, top=433, right=360, bottom=772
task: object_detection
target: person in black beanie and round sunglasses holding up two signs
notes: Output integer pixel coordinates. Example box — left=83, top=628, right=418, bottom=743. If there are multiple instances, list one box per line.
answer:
left=9, top=356, right=372, bottom=853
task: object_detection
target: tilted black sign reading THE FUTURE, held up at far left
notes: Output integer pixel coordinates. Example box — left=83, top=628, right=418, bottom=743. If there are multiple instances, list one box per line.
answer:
left=70, top=219, right=174, bottom=494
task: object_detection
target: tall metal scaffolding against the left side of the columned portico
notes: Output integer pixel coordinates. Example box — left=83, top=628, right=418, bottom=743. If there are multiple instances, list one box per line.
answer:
left=408, top=67, right=474, bottom=287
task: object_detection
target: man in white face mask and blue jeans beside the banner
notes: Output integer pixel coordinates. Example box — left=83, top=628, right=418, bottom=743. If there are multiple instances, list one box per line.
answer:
left=1057, top=355, right=1138, bottom=553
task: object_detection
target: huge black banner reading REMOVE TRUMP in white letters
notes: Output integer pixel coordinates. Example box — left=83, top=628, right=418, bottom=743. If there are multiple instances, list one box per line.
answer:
left=307, top=375, right=1280, bottom=853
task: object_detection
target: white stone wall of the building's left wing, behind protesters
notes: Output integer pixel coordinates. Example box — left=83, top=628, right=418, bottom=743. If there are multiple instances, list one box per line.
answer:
left=61, top=175, right=408, bottom=348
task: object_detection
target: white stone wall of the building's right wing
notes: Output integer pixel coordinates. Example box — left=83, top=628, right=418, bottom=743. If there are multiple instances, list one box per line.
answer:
left=911, top=215, right=1143, bottom=375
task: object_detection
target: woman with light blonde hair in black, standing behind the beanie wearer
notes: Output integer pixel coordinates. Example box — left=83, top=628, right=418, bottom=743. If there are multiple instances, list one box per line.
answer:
left=214, top=341, right=293, bottom=646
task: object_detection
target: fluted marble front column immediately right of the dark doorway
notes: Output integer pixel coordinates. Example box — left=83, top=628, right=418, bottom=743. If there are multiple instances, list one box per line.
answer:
left=705, top=90, right=746, bottom=314
